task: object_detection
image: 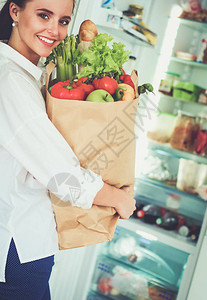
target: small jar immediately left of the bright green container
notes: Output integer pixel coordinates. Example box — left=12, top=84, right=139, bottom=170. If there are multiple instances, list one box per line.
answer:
left=159, top=72, right=180, bottom=96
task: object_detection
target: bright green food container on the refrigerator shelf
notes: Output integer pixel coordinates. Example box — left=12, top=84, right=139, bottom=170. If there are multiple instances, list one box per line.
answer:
left=173, top=81, right=202, bottom=102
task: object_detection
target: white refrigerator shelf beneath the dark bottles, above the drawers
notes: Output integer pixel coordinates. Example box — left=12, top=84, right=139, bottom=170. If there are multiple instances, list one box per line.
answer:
left=118, top=218, right=196, bottom=254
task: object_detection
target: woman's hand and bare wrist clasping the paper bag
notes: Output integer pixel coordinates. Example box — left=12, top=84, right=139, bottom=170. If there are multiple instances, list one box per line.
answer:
left=93, top=183, right=136, bottom=219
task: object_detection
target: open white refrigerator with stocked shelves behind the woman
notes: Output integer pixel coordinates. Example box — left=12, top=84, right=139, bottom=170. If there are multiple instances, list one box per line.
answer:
left=50, top=0, right=207, bottom=300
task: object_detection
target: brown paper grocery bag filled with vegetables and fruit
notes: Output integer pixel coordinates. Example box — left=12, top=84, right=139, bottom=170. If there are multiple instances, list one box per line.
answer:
left=46, top=63, right=138, bottom=249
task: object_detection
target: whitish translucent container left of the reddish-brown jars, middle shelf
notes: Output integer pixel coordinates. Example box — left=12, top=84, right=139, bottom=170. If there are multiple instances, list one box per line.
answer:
left=147, top=113, right=176, bottom=143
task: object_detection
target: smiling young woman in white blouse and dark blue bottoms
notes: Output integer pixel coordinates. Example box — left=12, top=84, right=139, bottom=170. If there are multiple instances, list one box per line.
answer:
left=0, top=0, right=135, bottom=300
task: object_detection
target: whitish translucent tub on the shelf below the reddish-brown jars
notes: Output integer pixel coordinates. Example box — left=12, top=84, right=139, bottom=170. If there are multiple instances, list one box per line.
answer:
left=176, top=158, right=207, bottom=194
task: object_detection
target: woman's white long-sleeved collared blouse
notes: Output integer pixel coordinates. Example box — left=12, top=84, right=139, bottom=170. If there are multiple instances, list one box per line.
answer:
left=0, top=42, right=103, bottom=282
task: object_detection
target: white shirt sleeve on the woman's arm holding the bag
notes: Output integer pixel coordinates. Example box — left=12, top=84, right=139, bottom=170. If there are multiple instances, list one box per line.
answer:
left=0, top=72, right=103, bottom=208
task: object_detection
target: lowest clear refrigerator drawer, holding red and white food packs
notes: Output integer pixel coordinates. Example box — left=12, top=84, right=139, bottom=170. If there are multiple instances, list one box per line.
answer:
left=91, top=255, right=177, bottom=300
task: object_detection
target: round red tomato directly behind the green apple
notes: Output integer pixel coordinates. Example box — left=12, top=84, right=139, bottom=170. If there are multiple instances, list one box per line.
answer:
left=93, top=76, right=118, bottom=95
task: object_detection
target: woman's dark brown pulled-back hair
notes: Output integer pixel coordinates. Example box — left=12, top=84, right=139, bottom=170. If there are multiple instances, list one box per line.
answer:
left=0, top=0, right=75, bottom=40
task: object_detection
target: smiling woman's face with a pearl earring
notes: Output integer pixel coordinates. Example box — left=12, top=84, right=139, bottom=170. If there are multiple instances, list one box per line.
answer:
left=9, top=0, right=73, bottom=64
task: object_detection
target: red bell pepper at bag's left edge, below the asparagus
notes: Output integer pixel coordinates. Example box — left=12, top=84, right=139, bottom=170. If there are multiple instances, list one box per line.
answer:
left=51, top=80, right=86, bottom=100
